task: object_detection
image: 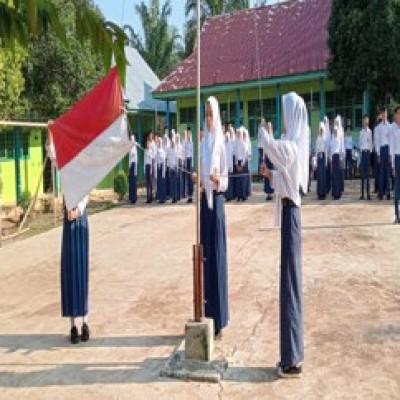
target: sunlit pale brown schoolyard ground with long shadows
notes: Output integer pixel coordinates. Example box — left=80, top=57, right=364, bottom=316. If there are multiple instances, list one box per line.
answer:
left=0, top=184, right=400, bottom=400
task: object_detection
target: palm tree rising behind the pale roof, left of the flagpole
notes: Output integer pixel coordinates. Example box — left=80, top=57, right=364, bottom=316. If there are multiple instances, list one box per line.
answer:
left=134, top=0, right=182, bottom=79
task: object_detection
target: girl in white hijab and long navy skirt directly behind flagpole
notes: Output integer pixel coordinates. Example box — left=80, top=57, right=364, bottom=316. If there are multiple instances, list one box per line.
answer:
left=192, top=97, right=229, bottom=339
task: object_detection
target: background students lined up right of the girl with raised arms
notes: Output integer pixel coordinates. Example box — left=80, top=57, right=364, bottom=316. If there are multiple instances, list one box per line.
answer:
left=310, top=106, right=400, bottom=224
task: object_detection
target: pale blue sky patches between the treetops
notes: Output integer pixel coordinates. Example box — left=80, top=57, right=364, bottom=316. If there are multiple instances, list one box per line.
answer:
left=94, top=0, right=277, bottom=37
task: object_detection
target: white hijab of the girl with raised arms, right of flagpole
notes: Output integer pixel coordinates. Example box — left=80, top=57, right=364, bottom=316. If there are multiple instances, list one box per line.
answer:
left=283, top=92, right=310, bottom=194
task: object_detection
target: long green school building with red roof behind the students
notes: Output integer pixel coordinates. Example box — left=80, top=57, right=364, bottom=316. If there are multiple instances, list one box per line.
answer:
left=154, top=0, right=369, bottom=171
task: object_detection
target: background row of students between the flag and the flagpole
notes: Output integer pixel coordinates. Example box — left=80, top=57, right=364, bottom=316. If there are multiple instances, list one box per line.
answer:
left=129, top=127, right=194, bottom=204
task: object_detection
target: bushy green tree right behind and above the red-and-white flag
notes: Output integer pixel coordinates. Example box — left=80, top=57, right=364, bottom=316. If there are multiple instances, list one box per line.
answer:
left=21, top=0, right=105, bottom=119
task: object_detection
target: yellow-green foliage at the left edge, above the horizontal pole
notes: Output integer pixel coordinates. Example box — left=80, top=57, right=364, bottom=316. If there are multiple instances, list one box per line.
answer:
left=0, top=47, right=25, bottom=119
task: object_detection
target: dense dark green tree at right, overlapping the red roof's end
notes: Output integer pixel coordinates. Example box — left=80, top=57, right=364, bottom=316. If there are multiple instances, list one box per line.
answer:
left=328, top=0, right=400, bottom=113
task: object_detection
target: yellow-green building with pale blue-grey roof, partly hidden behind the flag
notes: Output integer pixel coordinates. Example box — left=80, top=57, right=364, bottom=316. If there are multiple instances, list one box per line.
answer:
left=0, top=47, right=176, bottom=206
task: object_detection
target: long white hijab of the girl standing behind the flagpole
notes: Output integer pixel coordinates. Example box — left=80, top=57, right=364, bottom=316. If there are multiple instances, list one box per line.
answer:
left=201, top=96, right=224, bottom=210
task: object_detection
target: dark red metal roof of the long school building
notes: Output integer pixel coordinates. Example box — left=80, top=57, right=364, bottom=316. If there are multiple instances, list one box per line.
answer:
left=155, top=0, right=331, bottom=93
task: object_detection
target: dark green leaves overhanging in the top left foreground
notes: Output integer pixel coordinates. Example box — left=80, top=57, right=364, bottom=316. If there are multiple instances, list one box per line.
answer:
left=0, top=0, right=127, bottom=77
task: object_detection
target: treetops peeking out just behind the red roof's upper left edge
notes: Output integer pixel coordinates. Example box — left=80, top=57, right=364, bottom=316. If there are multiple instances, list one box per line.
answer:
left=185, top=0, right=267, bottom=56
